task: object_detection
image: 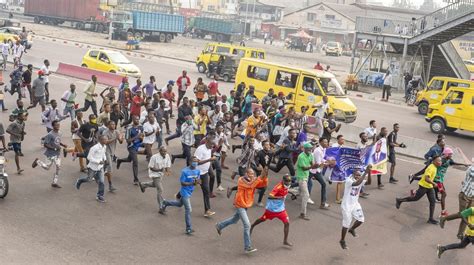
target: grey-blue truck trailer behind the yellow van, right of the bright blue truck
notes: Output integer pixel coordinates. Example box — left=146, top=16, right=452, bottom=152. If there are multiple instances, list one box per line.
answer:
left=189, top=16, right=244, bottom=42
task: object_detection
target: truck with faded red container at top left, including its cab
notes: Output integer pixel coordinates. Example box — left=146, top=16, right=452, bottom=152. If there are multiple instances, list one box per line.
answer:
left=24, top=0, right=127, bottom=33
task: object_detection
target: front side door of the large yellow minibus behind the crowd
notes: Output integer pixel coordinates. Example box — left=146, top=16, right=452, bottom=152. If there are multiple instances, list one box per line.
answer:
left=296, top=75, right=323, bottom=115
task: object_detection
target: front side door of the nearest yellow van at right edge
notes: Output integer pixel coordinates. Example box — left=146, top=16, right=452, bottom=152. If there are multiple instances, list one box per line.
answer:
left=441, top=90, right=465, bottom=128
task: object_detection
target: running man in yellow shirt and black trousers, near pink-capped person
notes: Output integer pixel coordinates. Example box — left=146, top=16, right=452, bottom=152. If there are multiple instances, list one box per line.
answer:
left=395, top=156, right=442, bottom=224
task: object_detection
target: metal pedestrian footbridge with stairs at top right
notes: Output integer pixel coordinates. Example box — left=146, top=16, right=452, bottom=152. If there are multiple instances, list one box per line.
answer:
left=356, top=0, right=474, bottom=80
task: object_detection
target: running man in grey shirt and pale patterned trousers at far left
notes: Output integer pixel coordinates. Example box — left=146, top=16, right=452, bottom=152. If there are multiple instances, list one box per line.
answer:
left=31, top=120, right=67, bottom=188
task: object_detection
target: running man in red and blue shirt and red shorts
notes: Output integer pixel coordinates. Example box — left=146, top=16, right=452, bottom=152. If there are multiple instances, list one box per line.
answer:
left=250, top=173, right=296, bottom=247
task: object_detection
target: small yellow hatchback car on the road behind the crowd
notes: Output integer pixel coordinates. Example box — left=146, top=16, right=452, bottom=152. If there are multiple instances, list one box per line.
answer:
left=81, top=49, right=142, bottom=78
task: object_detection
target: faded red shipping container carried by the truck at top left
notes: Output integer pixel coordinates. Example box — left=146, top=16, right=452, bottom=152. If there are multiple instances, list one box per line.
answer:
left=25, top=0, right=101, bottom=21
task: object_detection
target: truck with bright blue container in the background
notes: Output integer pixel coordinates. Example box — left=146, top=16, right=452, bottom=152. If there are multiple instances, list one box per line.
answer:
left=113, top=11, right=185, bottom=42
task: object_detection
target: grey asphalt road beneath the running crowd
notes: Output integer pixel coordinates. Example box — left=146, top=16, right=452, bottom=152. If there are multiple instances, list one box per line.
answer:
left=0, top=37, right=472, bottom=264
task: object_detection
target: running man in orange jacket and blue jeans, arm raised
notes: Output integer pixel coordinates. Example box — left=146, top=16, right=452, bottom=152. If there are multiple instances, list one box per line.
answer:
left=216, top=168, right=268, bottom=254
